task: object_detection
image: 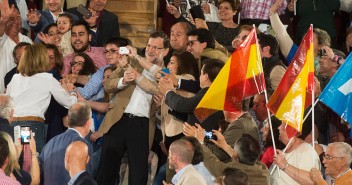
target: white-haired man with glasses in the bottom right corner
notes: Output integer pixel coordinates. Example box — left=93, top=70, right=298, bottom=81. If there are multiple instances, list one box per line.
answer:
left=310, top=142, right=352, bottom=185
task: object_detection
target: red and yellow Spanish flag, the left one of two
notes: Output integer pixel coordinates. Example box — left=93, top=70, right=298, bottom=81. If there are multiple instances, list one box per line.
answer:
left=194, top=29, right=265, bottom=122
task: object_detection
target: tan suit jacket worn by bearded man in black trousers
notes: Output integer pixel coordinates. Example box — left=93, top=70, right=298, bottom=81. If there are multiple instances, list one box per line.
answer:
left=99, top=62, right=158, bottom=149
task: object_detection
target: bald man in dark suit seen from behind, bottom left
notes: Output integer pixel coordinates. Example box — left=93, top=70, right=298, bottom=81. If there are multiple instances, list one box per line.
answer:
left=65, top=141, right=98, bottom=185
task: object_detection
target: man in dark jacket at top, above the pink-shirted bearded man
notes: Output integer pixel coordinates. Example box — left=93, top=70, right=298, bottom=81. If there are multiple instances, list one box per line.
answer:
left=67, top=0, right=120, bottom=47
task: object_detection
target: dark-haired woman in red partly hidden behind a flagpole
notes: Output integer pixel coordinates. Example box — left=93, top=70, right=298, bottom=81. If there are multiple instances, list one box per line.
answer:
left=260, top=116, right=285, bottom=168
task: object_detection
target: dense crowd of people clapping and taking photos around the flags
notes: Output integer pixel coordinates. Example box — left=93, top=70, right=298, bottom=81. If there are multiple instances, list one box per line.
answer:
left=0, top=0, right=352, bottom=185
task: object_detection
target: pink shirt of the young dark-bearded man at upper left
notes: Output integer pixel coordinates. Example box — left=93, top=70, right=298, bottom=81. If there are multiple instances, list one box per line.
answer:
left=62, top=47, right=108, bottom=76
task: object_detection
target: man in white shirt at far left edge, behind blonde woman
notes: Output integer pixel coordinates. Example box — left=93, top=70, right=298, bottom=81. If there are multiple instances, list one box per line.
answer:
left=0, top=0, right=32, bottom=93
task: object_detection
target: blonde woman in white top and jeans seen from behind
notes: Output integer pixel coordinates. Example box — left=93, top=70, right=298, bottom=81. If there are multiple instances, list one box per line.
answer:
left=6, top=44, right=77, bottom=152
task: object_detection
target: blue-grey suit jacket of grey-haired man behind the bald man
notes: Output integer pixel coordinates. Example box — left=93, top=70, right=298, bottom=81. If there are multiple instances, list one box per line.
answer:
left=39, top=129, right=93, bottom=185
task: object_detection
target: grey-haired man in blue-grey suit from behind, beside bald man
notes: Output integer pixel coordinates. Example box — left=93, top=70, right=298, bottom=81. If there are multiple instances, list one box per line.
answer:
left=39, top=102, right=93, bottom=185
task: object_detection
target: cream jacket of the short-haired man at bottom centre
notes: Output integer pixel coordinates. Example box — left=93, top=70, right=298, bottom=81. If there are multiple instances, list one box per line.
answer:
left=175, top=165, right=207, bottom=185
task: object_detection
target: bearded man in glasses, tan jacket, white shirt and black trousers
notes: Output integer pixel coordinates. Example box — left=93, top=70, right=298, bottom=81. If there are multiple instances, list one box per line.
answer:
left=97, top=32, right=170, bottom=185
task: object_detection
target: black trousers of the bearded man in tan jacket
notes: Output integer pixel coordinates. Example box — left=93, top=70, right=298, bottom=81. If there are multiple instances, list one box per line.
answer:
left=97, top=114, right=149, bottom=185
